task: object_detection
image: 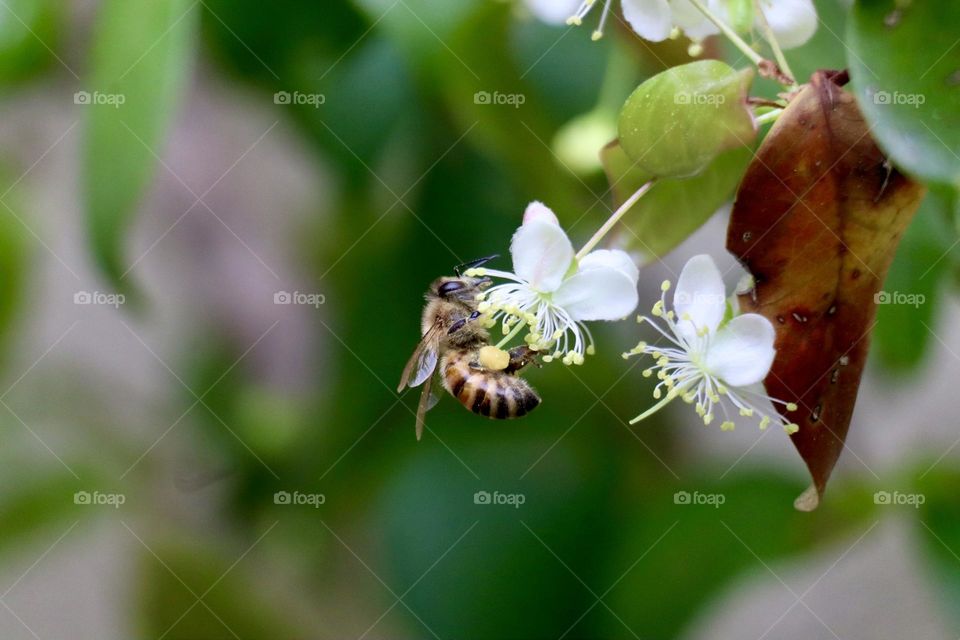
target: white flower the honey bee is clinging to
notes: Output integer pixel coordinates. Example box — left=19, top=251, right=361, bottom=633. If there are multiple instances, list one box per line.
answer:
left=468, top=202, right=640, bottom=364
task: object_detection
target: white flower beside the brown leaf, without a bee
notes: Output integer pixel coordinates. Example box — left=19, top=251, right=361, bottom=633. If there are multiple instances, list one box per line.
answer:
left=623, top=255, right=798, bottom=433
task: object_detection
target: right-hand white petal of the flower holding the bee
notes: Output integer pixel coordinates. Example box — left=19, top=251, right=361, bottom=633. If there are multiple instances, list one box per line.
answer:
left=553, top=262, right=637, bottom=320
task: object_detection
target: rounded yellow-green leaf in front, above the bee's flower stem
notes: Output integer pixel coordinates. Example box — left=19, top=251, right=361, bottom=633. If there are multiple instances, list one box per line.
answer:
left=618, top=60, right=756, bottom=178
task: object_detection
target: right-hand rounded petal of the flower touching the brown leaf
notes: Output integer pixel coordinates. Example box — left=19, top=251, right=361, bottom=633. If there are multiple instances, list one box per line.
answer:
left=705, top=313, right=776, bottom=387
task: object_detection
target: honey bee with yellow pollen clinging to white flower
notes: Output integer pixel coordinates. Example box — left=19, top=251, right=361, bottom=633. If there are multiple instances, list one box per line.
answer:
left=397, top=256, right=540, bottom=440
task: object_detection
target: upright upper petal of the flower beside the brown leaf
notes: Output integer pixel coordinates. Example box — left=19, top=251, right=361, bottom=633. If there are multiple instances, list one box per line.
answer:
left=673, top=254, right=727, bottom=343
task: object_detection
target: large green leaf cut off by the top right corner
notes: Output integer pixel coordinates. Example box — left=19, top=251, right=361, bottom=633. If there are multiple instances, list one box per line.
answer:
left=847, top=0, right=960, bottom=188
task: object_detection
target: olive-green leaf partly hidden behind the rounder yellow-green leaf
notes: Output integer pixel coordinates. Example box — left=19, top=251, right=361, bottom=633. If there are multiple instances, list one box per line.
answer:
left=601, top=142, right=752, bottom=260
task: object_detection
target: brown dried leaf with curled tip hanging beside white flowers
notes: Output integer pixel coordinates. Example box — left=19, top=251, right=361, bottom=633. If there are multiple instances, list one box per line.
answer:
left=727, top=71, right=924, bottom=510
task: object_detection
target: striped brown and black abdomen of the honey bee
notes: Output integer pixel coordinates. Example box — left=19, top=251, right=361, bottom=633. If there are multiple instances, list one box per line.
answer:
left=443, top=349, right=540, bottom=420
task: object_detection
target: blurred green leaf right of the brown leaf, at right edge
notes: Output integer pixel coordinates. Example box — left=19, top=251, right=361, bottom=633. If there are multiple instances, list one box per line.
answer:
left=874, top=189, right=957, bottom=373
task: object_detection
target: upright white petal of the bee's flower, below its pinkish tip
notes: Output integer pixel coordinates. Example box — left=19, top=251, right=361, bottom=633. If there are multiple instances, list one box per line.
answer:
left=510, top=214, right=573, bottom=293
